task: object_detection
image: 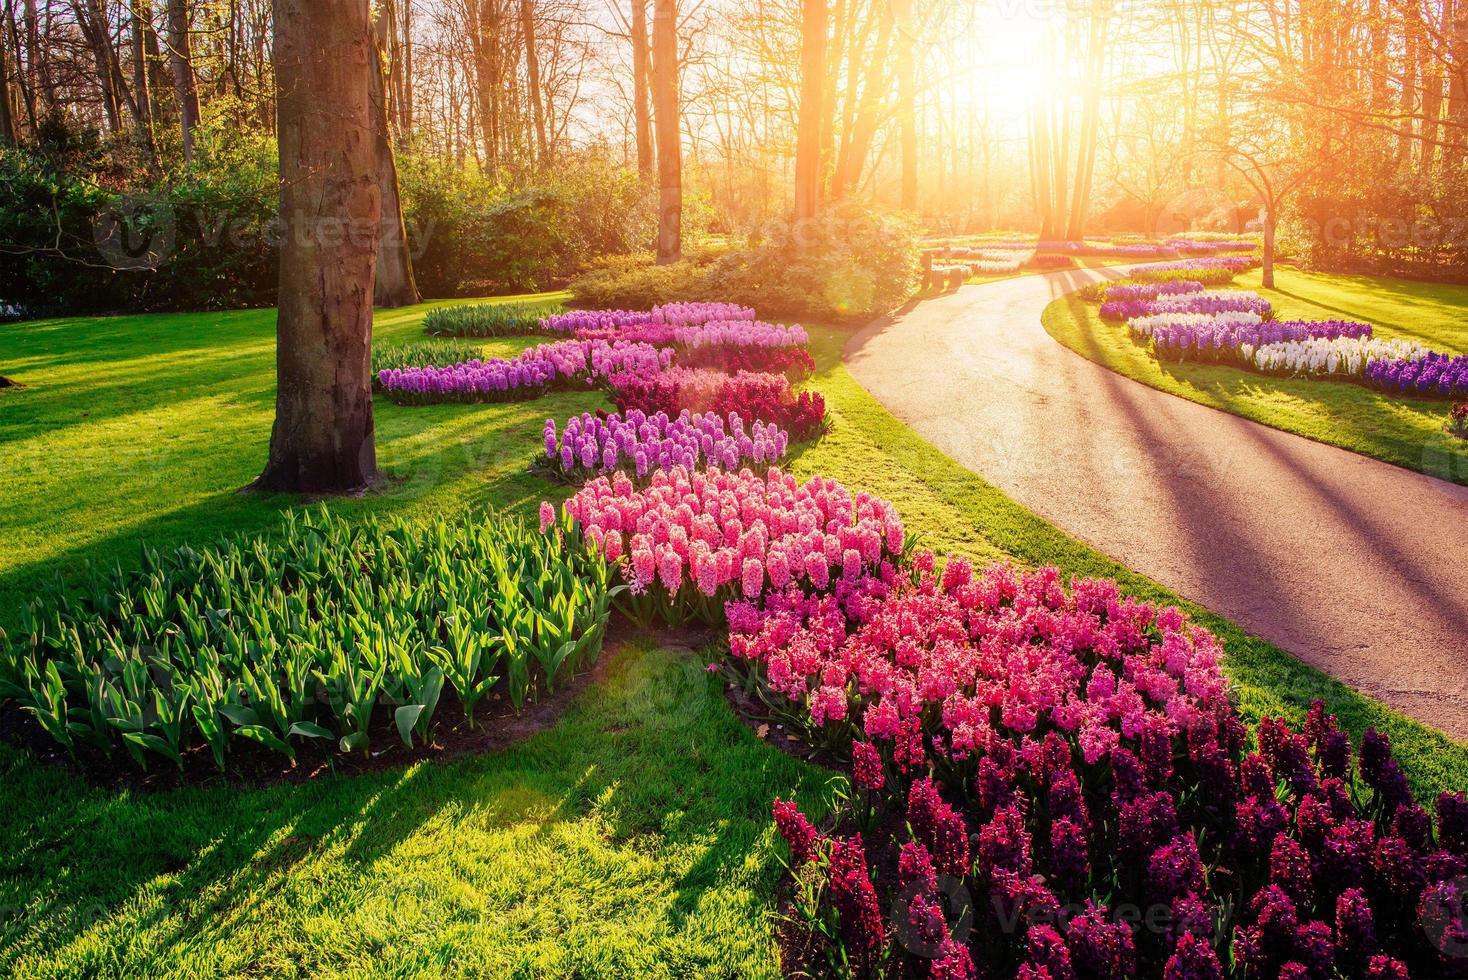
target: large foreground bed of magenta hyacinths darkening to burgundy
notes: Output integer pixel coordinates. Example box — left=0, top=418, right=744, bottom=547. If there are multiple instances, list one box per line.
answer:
left=745, top=556, right=1468, bottom=979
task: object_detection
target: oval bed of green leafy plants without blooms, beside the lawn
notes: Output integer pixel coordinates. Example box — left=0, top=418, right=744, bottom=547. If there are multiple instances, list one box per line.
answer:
left=0, top=509, right=612, bottom=767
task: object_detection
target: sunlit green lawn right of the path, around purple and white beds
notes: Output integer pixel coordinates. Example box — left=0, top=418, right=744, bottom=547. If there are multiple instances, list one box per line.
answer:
left=1044, top=268, right=1468, bottom=484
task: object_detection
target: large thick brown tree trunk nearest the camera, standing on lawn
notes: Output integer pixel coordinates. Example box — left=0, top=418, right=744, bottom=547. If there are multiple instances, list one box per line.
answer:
left=255, top=0, right=382, bottom=493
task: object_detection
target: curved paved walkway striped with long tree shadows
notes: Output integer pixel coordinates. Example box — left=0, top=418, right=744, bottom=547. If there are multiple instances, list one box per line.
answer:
left=846, top=268, right=1468, bottom=741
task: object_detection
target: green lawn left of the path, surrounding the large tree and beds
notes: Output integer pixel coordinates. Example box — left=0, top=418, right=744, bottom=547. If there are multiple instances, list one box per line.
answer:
left=0, top=294, right=1468, bottom=977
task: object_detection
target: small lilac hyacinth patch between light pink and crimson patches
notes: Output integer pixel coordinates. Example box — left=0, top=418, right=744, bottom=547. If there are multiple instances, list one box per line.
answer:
left=545, top=409, right=790, bottom=480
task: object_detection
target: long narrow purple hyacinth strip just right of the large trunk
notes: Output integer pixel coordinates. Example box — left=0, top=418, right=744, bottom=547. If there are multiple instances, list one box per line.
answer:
left=377, top=340, right=672, bottom=405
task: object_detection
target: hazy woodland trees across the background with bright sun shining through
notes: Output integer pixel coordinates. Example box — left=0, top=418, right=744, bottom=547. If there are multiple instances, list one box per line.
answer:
left=0, top=0, right=1468, bottom=305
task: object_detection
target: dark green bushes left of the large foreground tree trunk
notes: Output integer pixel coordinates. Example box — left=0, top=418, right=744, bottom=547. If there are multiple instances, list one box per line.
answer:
left=0, top=120, right=279, bottom=315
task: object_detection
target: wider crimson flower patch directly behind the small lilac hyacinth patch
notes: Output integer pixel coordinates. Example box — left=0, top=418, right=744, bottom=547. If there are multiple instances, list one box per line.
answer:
left=609, top=367, right=825, bottom=442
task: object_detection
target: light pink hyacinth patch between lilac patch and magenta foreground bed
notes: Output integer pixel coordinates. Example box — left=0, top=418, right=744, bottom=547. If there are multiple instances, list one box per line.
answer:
left=554, top=465, right=904, bottom=625
